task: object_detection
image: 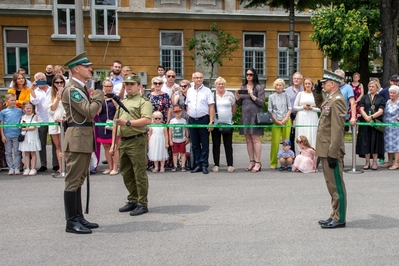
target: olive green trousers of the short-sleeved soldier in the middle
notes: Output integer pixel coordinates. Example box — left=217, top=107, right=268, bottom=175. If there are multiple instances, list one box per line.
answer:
left=118, top=136, right=148, bottom=206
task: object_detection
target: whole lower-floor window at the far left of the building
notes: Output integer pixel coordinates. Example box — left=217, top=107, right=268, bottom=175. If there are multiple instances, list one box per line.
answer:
left=3, top=28, right=29, bottom=75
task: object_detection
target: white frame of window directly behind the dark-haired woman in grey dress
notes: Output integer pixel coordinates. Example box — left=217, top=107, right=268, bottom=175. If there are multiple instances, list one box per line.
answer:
left=242, top=32, right=266, bottom=80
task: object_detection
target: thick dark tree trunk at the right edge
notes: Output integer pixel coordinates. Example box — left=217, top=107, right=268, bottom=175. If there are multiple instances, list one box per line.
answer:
left=380, top=0, right=399, bottom=87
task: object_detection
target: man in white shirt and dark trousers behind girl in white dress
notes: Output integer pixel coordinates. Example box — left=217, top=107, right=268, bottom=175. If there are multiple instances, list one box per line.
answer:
left=30, top=72, right=59, bottom=173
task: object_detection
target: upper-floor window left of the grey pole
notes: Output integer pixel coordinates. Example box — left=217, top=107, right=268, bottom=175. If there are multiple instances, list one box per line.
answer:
left=52, top=0, right=76, bottom=38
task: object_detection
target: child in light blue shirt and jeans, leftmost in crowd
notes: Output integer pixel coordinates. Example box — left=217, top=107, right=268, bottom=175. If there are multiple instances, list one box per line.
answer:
left=0, top=93, right=22, bottom=175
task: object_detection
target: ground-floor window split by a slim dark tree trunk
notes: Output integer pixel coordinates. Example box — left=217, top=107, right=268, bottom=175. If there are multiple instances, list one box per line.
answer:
left=278, top=33, right=299, bottom=79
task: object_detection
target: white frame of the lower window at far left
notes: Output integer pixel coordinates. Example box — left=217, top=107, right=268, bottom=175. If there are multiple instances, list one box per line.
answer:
left=3, top=27, right=30, bottom=78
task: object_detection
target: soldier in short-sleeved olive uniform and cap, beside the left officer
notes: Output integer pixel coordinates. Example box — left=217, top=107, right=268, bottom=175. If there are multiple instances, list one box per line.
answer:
left=110, top=75, right=152, bottom=216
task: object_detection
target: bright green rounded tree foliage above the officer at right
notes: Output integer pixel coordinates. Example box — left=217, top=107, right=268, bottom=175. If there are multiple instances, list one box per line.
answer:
left=310, top=4, right=370, bottom=60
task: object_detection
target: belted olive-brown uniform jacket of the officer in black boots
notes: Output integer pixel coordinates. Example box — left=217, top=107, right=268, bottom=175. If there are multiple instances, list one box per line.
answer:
left=61, top=78, right=104, bottom=153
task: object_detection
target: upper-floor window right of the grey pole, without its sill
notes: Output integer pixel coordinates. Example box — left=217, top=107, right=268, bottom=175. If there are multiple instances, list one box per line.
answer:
left=91, top=0, right=118, bottom=36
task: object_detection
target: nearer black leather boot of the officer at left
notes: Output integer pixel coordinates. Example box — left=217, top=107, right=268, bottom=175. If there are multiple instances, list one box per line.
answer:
left=64, top=191, right=91, bottom=234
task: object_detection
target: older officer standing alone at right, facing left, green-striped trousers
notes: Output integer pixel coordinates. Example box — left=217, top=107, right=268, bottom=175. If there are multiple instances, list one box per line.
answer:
left=316, top=70, right=347, bottom=228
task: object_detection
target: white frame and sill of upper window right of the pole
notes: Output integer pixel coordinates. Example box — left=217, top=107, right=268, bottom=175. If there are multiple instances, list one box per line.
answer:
left=89, top=0, right=121, bottom=41
